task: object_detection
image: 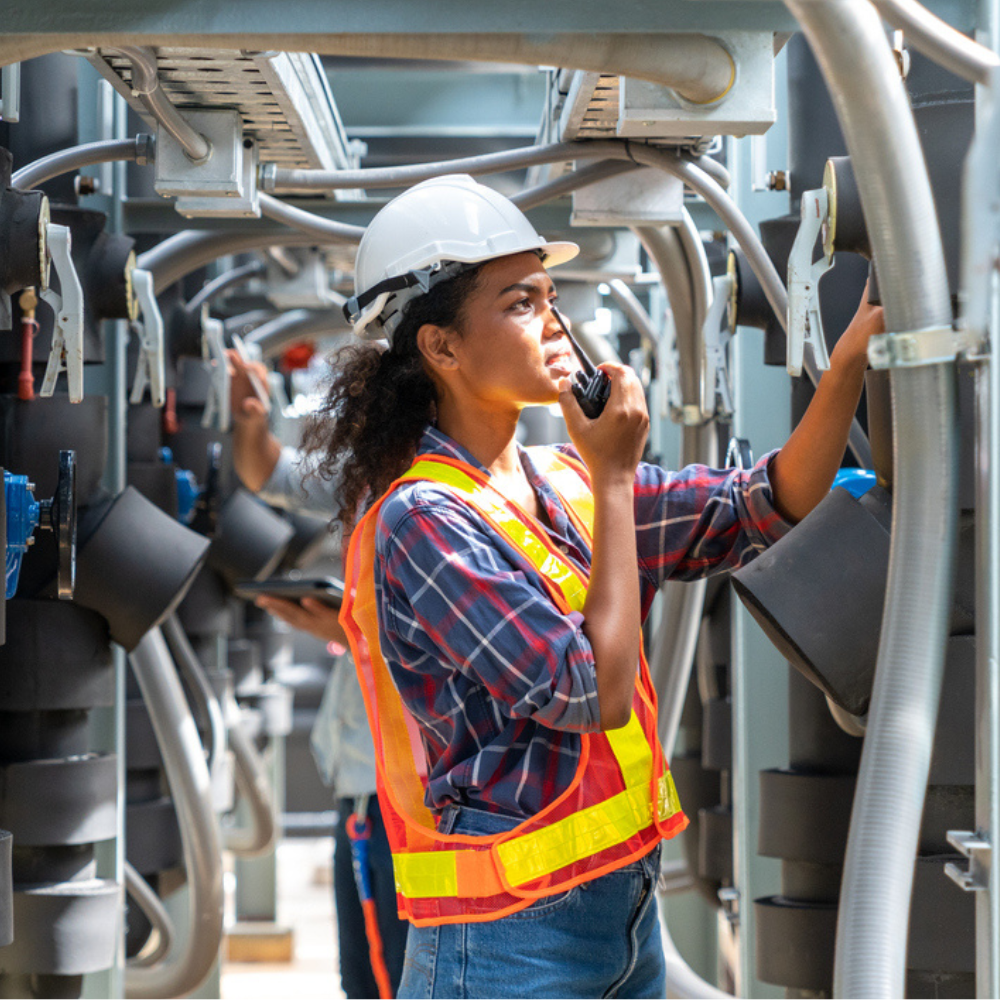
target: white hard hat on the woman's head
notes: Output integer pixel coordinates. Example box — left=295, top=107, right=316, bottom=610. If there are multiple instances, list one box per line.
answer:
left=344, top=174, right=580, bottom=339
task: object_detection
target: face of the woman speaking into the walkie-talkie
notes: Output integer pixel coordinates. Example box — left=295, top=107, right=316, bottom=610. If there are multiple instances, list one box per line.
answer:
left=436, top=253, right=579, bottom=405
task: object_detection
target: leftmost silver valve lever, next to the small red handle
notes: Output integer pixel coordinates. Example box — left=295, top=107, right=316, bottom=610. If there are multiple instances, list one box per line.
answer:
left=38, top=222, right=83, bottom=403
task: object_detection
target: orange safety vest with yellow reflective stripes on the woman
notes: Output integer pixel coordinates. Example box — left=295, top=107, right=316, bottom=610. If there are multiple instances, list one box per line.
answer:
left=341, top=448, right=688, bottom=926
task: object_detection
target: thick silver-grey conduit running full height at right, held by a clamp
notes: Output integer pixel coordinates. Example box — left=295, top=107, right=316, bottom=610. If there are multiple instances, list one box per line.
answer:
left=786, top=0, right=957, bottom=997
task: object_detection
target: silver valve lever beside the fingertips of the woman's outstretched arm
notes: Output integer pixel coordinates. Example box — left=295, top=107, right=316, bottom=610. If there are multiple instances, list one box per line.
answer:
left=785, top=188, right=833, bottom=378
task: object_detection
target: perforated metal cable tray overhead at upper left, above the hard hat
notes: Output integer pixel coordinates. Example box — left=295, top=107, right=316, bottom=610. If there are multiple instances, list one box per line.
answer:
left=86, top=47, right=356, bottom=170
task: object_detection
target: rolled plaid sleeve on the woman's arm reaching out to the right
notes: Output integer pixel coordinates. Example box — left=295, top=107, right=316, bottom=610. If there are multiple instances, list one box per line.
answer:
left=635, top=451, right=792, bottom=585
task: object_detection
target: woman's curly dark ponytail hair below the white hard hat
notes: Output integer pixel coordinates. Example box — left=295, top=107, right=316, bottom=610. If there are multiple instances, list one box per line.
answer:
left=303, top=265, right=482, bottom=537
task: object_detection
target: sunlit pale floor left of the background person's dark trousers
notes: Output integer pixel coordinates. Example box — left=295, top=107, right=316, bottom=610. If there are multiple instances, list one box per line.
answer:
left=222, top=837, right=344, bottom=1000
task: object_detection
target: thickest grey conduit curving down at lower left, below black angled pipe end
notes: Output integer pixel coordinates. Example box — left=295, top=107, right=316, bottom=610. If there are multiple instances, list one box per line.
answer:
left=125, top=628, right=223, bottom=998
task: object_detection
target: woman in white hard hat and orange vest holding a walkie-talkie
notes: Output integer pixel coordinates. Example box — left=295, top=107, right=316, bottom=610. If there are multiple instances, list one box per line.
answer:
left=312, top=176, right=881, bottom=997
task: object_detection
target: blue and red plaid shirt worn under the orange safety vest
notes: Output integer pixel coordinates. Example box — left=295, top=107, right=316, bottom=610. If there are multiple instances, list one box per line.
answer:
left=375, top=427, right=789, bottom=817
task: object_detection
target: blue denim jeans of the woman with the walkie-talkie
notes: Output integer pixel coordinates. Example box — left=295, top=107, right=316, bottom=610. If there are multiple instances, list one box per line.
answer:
left=398, top=806, right=666, bottom=998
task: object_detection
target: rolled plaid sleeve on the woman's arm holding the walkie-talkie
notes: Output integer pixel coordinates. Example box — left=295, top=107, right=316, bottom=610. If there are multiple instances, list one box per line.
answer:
left=376, top=484, right=600, bottom=732
